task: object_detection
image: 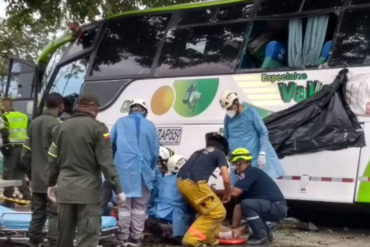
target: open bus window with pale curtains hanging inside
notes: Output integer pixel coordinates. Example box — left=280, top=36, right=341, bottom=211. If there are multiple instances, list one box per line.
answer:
left=239, top=13, right=338, bottom=70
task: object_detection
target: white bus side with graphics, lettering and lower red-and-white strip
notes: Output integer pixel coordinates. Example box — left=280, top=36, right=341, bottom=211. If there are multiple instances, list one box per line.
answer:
left=98, top=69, right=363, bottom=203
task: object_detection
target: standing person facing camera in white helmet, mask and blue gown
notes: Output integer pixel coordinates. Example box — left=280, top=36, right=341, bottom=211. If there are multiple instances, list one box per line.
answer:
left=220, top=91, right=284, bottom=183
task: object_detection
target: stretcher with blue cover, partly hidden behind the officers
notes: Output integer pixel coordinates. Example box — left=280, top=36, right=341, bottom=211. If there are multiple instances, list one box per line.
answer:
left=0, top=205, right=118, bottom=243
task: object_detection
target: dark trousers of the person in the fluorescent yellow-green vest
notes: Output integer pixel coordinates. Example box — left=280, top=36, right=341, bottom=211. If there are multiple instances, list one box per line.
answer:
left=3, top=146, right=31, bottom=200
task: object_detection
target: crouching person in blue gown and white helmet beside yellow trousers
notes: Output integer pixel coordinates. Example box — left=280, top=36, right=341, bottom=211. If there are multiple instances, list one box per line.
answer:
left=146, top=153, right=191, bottom=244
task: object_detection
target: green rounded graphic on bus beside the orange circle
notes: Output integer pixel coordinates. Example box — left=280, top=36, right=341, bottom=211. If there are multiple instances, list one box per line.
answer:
left=174, top=78, right=219, bottom=117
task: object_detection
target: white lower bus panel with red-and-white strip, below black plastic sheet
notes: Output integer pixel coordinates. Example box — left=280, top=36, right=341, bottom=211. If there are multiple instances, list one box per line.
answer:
left=277, top=148, right=360, bottom=203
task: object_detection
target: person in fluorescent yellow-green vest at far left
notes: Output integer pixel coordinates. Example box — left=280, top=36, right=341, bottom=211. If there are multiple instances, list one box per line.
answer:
left=0, top=98, right=31, bottom=201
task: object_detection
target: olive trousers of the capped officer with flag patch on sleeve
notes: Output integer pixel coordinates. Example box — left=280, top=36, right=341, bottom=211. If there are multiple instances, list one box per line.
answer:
left=57, top=203, right=101, bottom=247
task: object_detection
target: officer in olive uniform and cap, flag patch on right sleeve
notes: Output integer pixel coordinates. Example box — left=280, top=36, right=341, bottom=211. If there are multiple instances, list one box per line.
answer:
left=48, top=95, right=125, bottom=247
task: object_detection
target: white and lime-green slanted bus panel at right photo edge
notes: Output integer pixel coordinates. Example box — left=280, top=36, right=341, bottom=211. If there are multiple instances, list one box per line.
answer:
left=355, top=119, right=370, bottom=203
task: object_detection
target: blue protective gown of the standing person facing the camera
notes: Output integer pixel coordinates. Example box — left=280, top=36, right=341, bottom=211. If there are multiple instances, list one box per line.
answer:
left=224, top=105, right=284, bottom=182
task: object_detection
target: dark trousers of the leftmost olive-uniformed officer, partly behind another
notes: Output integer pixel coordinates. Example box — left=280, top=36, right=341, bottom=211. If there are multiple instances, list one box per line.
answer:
left=28, top=193, right=58, bottom=247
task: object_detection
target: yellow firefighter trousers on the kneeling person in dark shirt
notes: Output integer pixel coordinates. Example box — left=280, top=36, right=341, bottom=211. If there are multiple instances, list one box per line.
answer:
left=177, top=179, right=226, bottom=246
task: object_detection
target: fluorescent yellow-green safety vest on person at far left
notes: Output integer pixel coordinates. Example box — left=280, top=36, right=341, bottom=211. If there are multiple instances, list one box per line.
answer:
left=4, top=111, right=28, bottom=144
